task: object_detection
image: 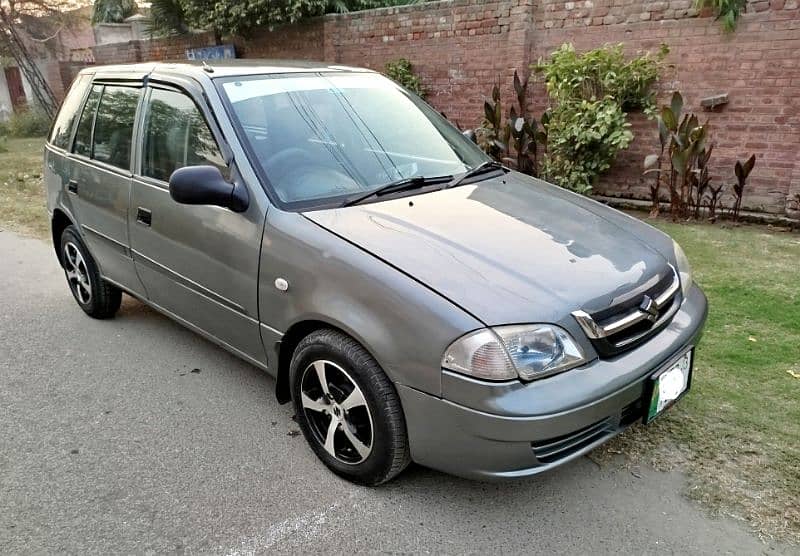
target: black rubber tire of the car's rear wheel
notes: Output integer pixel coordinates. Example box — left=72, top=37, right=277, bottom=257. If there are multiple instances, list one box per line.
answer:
left=59, top=226, right=122, bottom=319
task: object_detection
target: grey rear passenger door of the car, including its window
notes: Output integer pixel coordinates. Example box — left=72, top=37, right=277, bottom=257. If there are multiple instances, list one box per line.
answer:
left=67, top=79, right=143, bottom=293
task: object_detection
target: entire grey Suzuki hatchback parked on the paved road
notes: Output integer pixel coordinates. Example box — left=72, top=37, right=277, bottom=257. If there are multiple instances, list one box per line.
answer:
left=45, top=61, right=707, bottom=485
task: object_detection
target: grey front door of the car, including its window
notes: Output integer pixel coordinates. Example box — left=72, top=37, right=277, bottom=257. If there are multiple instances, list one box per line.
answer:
left=129, top=85, right=266, bottom=364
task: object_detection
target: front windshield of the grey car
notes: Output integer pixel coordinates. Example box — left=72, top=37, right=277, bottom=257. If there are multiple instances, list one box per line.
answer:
left=221, top=73, right=487, bottom=207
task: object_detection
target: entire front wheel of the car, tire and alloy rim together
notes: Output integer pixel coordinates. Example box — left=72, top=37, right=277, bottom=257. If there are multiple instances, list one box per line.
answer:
left=290, top=330, right=411, bottom=486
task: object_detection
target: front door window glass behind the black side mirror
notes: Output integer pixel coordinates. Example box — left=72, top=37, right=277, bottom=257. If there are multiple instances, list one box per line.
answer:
left=142, top=89, right=225, bottom=181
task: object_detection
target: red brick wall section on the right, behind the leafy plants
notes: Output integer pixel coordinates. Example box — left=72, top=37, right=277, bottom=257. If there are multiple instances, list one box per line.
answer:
left=531, top=0, right=800, bottom=213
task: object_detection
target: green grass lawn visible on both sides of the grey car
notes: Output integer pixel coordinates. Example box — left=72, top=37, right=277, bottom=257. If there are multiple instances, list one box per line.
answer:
left=0, top=139, right=800, bottom=541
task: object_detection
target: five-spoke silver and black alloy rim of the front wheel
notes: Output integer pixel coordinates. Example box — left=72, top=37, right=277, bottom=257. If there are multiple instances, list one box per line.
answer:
left=300, top=360, right=374, bottom=465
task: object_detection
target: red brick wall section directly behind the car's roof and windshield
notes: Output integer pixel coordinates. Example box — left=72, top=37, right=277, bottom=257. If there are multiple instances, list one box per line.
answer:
left=325, top=0, right=533, bottom=126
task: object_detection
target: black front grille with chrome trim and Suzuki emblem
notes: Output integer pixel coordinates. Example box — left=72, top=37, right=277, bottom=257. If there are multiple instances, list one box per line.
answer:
left=572, top=266, right=680, bottom=358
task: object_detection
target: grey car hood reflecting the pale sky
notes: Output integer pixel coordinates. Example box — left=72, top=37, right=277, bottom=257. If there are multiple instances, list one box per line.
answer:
left=305, top=173, right=669, bottom=325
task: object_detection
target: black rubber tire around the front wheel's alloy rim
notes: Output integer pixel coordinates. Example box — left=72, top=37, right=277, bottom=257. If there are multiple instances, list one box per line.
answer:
left=289, top=330, right=411, bottom=486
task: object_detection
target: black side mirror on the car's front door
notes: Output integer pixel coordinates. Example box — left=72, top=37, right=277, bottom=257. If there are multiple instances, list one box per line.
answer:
left=169, top=166, right=249, bottom=212
